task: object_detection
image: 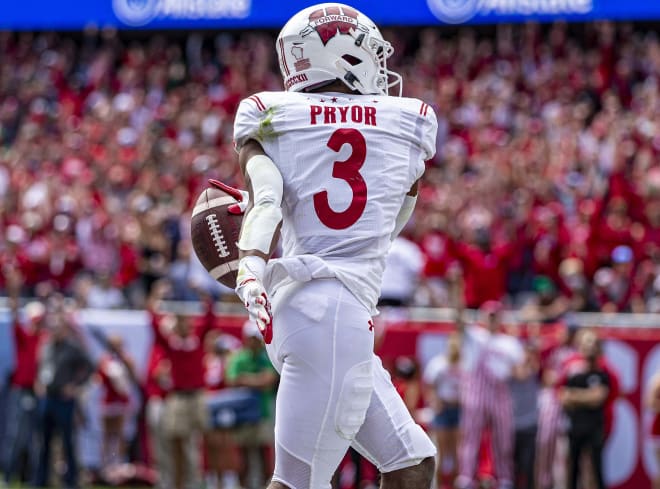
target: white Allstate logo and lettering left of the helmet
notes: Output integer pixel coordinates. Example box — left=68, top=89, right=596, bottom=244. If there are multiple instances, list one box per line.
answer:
left=112, top=0, right=251, bottom=27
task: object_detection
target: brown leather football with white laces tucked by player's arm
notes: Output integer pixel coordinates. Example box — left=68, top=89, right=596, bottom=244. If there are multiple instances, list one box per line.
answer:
left=190, top=188, right=243, bottom=289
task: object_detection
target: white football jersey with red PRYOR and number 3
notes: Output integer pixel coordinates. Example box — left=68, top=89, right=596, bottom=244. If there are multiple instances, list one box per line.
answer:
left=234, top=92, right=437, bottom=309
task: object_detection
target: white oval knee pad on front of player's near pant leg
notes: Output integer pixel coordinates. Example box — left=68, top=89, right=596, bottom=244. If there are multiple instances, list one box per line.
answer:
left=335, top=360, right=374, bottom=440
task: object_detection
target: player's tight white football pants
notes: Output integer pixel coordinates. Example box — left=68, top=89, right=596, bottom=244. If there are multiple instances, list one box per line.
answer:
left=267, top=279, right=435, bottom=489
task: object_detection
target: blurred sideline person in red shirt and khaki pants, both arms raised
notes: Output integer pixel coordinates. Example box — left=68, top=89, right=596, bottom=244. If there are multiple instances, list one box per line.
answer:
left=148, top=281, right=214, bottom=489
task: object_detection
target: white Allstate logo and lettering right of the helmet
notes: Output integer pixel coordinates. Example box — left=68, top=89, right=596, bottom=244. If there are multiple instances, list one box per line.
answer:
left=427, top=0, right=593, bottom=24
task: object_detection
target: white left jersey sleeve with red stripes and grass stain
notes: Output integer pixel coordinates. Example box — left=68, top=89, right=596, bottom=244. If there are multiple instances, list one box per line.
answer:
left=234, top=94, right=275, bottom=152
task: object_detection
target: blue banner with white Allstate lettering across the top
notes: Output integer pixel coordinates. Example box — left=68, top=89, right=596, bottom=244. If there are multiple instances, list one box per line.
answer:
left=0, top=0, right=660, bottom=30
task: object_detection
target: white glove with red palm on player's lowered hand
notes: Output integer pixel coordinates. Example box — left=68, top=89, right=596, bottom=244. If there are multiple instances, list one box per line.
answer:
left=236, top=256, right=273, bottom=344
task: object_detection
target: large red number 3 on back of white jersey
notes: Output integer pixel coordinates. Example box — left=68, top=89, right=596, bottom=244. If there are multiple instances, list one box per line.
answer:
left=314, top=129, right=367, bottom=229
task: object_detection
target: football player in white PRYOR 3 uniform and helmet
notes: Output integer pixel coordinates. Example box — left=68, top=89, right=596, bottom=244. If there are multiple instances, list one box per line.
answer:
left=216, top=3, right=437, bottom=489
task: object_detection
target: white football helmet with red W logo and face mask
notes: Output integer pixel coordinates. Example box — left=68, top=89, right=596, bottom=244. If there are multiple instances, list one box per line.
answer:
left=276, top=3, right=402, bottom=96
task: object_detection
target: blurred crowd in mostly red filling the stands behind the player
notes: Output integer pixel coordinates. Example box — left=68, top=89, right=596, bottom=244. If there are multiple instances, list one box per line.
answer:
left=0, top=22, right=660, bottom=312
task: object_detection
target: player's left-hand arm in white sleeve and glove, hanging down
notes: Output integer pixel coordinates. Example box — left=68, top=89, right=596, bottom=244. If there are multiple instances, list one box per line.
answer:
left=236, top=139, right=284, bottom=343
